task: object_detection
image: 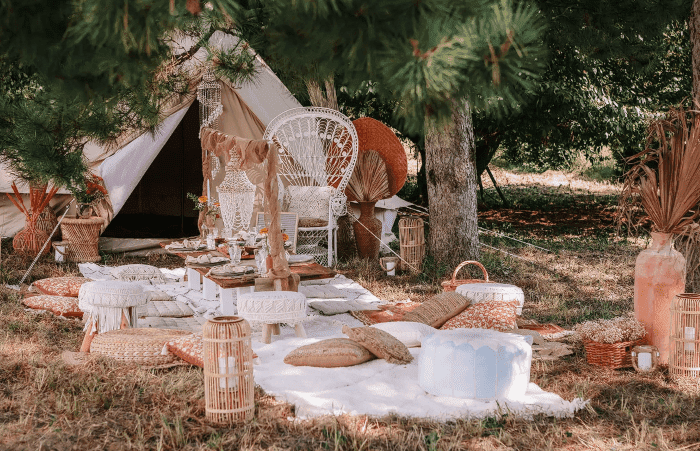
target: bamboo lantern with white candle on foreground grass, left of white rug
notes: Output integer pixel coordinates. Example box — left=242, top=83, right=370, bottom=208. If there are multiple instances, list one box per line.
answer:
left=202, top=316, right=255, bottom=424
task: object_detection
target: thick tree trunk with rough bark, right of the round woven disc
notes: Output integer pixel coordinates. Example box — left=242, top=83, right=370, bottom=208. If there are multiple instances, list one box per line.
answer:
left=425, top=101, right=479, bottom=267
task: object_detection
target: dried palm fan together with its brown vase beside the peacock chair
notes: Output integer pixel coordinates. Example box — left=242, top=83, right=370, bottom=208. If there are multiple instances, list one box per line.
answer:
left=345, top=150, right=391, bottom=259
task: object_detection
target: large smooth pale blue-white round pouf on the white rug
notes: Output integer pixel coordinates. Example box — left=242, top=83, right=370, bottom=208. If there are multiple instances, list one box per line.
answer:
left=418, top=329, right=532, bottom=399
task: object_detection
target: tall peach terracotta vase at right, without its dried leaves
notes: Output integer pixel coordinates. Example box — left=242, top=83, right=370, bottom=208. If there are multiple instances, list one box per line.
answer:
left=634, top=232, right=685, bottom=364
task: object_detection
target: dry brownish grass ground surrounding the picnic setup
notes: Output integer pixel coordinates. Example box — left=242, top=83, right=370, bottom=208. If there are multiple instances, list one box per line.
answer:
left=0, top=170, right=700, bottom=450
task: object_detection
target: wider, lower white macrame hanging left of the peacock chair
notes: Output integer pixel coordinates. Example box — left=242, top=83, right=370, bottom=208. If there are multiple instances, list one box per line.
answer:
left=218, top=148, right=255, bottom=233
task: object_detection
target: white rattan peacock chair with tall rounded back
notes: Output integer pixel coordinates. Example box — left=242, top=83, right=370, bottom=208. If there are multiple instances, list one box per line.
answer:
left=263, top=107, right=358, bottom=266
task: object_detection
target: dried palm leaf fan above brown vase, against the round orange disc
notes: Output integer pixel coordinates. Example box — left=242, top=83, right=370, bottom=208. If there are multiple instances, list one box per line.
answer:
left=345, top=150, right=391, bottom=202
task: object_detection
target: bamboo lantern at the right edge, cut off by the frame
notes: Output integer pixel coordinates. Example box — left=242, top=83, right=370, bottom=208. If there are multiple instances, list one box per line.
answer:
left=669, top=293, right=700, bottom=378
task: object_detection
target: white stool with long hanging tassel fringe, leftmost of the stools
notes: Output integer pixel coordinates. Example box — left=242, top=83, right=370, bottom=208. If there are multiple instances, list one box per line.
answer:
left=78, top=280, right=148, bottom=333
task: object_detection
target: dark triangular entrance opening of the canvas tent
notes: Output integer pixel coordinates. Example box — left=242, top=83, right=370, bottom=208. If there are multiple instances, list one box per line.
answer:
left=102, top=100, right=203, bottom=238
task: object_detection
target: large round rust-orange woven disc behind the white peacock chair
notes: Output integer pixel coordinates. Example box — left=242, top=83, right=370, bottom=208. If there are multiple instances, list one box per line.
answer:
left=346, top=117, right=408, bottom=201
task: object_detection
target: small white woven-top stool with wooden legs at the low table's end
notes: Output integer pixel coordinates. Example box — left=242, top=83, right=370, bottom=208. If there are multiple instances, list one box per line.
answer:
left=236, top=291, right=307, bottom=343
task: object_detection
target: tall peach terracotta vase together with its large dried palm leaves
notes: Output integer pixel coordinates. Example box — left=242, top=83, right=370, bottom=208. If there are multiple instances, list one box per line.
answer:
left=618, top=107, right=700, bottom=364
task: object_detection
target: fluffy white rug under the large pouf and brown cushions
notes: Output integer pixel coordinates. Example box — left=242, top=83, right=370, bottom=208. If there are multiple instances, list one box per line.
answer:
left=253, top=328, right=588, bottom=421
